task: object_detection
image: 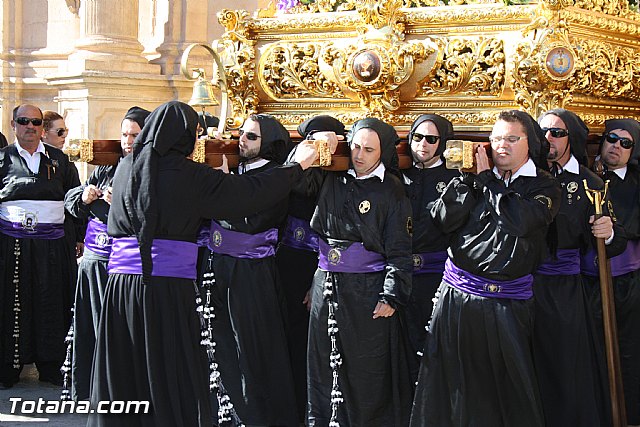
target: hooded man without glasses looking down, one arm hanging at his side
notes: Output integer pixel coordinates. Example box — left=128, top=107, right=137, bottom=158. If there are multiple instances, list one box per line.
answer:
left=299, top=118, right=413, bottom=427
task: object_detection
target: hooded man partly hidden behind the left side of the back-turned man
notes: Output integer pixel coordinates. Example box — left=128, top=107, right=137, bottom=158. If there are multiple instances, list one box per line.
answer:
left=63, top=107, right=151, bottom=400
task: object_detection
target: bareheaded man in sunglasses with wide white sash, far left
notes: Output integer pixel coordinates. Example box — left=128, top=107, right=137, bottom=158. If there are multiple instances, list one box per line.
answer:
left=0, top=105, right=79, bottom=388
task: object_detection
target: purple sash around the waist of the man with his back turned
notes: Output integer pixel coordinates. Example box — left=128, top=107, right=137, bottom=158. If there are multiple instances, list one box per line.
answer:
left=108, top=237, right=198, bottom=280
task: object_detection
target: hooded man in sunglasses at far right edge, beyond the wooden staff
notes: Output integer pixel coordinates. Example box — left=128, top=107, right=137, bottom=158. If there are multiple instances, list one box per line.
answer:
left=582, top=119, right=640, bottom=425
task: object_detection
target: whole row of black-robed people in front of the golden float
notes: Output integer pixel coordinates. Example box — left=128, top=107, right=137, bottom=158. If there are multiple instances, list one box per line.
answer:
left=0, top=101, right=640, bottom=427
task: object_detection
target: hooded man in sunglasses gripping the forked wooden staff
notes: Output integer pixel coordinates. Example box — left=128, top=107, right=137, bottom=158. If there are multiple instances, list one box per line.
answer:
left=533, top=108, right=626, bottom=427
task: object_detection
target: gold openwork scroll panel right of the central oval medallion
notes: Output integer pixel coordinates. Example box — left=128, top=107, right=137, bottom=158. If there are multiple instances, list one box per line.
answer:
left=417, top=37, right=506, bottom=97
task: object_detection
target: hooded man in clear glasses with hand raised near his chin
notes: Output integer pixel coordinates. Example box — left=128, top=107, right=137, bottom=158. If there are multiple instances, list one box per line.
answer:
left=411, top=110, right=560, bottom=427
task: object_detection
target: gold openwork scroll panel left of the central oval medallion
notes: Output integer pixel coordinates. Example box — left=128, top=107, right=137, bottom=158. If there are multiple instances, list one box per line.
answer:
left=259, top=42, right=344, bottom=100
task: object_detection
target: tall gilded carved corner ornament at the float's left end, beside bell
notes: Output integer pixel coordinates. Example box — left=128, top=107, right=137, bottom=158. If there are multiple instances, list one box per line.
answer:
left=214, top=9, right=260, bottom=128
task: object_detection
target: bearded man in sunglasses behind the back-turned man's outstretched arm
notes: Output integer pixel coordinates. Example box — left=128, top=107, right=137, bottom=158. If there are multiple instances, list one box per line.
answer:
left=203, top=114, right=298, bottom=426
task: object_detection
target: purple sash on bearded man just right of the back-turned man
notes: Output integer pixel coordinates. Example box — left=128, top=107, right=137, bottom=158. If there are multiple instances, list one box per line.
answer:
left=209, top=221, right=278, bottom=258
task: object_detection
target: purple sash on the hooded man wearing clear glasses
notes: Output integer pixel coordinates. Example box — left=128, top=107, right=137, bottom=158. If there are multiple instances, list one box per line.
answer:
left=442, top=259, right=533, bottom=299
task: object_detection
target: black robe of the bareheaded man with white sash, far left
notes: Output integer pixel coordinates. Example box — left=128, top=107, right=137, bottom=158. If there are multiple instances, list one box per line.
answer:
left=0, top=144, right=80, bottom=384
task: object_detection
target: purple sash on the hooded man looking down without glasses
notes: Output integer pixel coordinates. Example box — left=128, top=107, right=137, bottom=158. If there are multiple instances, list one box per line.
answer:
left=318, top=240, right=387, bottom=273
